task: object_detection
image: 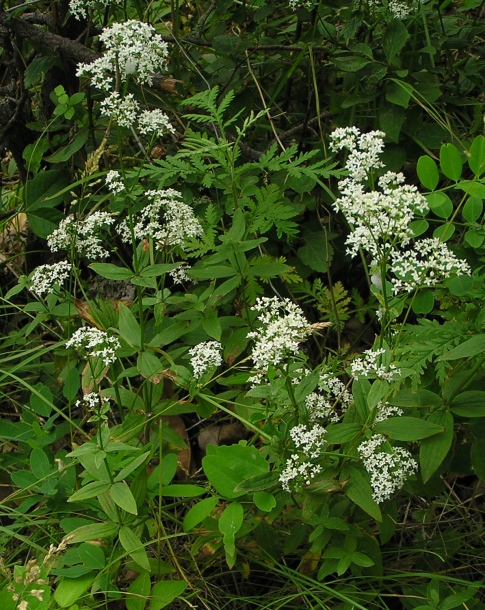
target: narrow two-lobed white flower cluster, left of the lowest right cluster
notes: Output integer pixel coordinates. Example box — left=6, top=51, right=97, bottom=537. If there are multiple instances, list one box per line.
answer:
left=279, top=424, right=326, bottom=491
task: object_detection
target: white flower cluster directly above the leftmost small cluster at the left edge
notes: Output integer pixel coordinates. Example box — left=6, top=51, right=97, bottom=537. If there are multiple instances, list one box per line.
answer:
left=47, top=212, right=115, bottom=260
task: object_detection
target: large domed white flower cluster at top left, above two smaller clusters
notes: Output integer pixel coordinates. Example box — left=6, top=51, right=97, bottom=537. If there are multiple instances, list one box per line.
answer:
left=76, top=19, right=168, bottom=92
